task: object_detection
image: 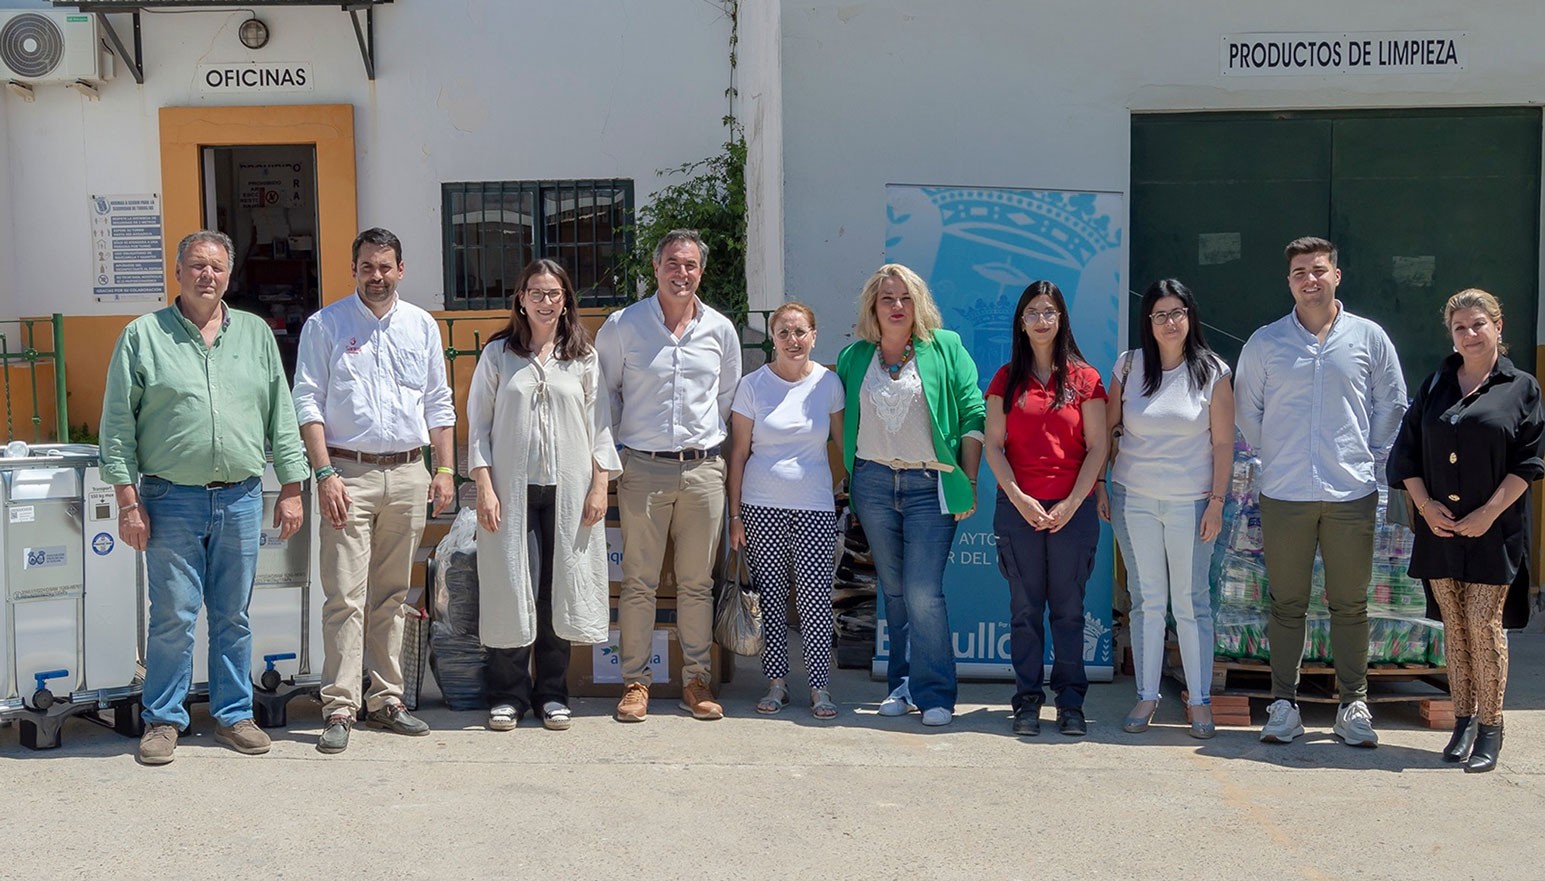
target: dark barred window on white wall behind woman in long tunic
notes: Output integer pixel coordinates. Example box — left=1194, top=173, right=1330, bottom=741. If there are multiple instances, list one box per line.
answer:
left=442, top=178, right=633, bottom=309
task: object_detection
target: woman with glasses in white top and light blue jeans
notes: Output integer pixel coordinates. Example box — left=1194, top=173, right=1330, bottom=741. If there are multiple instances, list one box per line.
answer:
left=1097, top=278, right=1234, bottom=737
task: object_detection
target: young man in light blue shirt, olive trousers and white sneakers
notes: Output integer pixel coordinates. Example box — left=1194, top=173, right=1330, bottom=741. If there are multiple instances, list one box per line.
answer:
left=1234, top=238, right=1406, bottom=747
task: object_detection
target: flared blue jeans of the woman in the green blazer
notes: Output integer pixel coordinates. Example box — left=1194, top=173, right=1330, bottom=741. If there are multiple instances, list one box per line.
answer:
left=848, top=459, right=958, bottom=711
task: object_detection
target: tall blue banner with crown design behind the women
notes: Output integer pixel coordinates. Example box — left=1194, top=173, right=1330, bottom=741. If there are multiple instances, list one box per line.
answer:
left=873, top=185, right=1126, bottom=682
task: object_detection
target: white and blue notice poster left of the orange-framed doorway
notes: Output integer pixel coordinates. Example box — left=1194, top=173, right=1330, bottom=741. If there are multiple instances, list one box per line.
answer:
left=87, top=193, right=167, bottom=303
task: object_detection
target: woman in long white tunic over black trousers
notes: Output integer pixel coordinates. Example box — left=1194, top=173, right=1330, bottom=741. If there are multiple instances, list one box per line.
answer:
left=467, top=260, right=623, bottom=731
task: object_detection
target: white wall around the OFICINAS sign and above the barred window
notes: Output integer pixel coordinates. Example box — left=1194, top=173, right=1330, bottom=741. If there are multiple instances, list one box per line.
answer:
left=0, top=0, right=729, bottom=317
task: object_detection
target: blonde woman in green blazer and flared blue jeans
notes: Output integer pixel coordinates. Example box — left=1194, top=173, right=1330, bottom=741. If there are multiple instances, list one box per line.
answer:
left=837, top=263, right=986, bottom=725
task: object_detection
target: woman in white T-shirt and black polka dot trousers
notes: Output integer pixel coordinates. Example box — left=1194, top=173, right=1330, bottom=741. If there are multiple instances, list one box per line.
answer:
left=728, top=303, right=844, bottom=719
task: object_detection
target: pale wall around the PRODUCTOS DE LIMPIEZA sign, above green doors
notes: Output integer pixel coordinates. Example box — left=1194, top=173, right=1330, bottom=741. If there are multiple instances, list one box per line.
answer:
left=782, top=0, right=1545, bottom=359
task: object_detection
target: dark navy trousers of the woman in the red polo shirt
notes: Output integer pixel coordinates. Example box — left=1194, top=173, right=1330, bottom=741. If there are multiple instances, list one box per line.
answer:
left=992, top=490, right=1100, bottom=716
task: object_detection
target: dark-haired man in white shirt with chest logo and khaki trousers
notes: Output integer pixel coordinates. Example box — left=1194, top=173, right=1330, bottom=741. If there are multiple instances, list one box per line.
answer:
left=295, top=227, right=456, bottom=753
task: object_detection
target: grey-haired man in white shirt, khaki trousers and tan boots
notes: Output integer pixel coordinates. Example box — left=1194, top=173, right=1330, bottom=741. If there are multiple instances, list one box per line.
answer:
left=595, top=229, right=740, bottom=722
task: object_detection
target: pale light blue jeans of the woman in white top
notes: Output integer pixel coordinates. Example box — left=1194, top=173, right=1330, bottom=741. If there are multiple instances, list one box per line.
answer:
left=1111, top=481, right=1216, bottom=705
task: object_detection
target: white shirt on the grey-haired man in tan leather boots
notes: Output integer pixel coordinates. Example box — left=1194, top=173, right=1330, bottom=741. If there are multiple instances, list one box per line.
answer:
left=595, top=294, right=740, bottom=453
